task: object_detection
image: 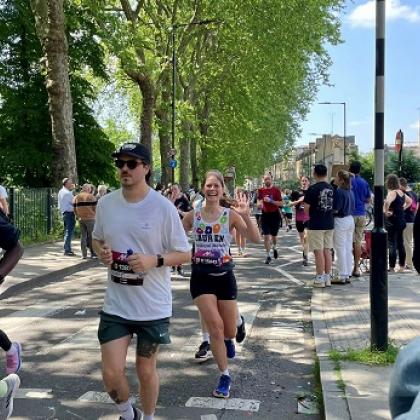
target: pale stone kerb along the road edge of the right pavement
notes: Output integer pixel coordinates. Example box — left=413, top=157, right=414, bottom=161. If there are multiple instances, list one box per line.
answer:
left=311, top=289, right=351, bottom=420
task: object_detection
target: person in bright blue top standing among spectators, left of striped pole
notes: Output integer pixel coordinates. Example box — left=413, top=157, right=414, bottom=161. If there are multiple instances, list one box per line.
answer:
left=349, top=161, right=372, bottom=277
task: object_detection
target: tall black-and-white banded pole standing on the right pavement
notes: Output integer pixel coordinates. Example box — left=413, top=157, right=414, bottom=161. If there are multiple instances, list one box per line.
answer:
left=370, top=0, right=388, bottom=351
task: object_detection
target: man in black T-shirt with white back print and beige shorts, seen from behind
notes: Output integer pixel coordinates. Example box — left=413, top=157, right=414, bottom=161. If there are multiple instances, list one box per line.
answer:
left=303, top=164, right=334, bottom=287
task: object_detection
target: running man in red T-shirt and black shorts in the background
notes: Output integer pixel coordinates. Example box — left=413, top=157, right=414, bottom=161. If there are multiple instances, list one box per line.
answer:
left=258, top=174, right=282, bottom=264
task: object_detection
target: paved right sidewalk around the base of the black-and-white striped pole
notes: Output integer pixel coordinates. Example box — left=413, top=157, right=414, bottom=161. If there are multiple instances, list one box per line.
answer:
left=311, top=272, right=420, bottom=420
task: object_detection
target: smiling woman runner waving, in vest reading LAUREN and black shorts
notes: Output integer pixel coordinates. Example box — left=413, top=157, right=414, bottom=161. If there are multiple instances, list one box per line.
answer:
left=183, top=170, right=260, bottom=398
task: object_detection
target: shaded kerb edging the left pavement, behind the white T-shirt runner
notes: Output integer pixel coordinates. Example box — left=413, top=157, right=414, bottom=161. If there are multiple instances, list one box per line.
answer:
left=0, top=259, right=99, bottom=300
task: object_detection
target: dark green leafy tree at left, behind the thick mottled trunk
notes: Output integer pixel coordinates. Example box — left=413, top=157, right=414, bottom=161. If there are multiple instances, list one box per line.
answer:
left=0, top=0, right=116, bottom=187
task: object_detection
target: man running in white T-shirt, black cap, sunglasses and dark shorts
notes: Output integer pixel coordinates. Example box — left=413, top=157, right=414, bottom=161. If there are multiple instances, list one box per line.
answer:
left=93, top=143, right=191, bottom=420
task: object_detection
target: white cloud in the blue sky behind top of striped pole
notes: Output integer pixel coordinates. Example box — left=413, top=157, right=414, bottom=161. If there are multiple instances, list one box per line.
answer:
left=348, top=0, right=420, bottom=28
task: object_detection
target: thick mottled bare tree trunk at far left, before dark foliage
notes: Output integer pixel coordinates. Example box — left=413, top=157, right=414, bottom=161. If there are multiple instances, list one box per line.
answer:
left=31, top=0, right=78, bottom=185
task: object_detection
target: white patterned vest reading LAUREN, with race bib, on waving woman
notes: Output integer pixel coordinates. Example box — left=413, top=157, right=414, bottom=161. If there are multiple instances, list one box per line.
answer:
left=193, top=208, right=232, bottom=267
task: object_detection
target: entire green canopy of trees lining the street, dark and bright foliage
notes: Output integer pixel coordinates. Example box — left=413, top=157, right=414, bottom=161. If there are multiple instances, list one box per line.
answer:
left=0, top=0, right=343, bottom=186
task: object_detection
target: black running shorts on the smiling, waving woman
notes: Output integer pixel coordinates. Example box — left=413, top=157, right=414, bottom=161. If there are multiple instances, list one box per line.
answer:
left=190, top=264, right=238, bottom=300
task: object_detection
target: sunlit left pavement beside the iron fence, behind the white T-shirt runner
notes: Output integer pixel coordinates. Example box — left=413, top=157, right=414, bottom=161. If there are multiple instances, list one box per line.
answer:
left=0, top=240, right=98, bottom=299
